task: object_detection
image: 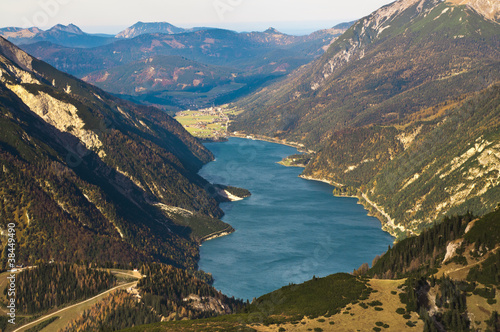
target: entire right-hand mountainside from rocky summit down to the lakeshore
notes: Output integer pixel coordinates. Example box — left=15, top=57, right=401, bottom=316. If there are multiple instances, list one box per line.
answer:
left=230, top=0, right=500, bottom=237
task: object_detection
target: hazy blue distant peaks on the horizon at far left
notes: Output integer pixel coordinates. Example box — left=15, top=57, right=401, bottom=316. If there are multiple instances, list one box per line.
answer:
left=0, top=24, right=113, bottom=48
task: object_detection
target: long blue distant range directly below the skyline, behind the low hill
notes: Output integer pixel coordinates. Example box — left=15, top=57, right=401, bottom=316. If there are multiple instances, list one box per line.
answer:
left=23, top=29, right=348, bottom=77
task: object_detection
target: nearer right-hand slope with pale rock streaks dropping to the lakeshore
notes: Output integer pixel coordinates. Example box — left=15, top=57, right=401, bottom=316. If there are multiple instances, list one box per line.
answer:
left=304, top=84, right=500, bottom=236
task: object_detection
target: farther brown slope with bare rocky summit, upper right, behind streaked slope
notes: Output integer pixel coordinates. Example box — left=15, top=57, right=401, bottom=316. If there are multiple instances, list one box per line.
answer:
left=234, top=0, right=500, bottom=141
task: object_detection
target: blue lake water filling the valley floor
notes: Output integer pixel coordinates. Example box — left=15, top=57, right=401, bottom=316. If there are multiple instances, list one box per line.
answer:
left=199, top=138, right=393, bottom=300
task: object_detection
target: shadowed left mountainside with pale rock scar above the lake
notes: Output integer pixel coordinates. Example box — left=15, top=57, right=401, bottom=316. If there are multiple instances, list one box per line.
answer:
left=0, top=39, right=230, bottom=268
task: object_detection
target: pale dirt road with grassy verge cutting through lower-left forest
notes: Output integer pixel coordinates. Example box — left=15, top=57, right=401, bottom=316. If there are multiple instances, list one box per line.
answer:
left=13, top=271, right=139, bottom=332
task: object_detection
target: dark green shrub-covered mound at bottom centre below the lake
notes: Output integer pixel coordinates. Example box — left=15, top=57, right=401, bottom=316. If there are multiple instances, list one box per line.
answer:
left=124, top=273, right=371, bottom=332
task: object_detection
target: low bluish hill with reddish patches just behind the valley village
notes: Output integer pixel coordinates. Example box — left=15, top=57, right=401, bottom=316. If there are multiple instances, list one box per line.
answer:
left=82, top=55, right=245, bottom=109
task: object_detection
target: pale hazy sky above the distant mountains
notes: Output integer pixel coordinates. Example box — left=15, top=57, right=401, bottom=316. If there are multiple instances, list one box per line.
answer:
left=0, top=0, right=392, bottom=34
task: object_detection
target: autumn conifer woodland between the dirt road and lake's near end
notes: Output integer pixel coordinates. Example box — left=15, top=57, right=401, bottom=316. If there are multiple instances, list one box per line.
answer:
left=64, top=264, right=244, bottom=332
